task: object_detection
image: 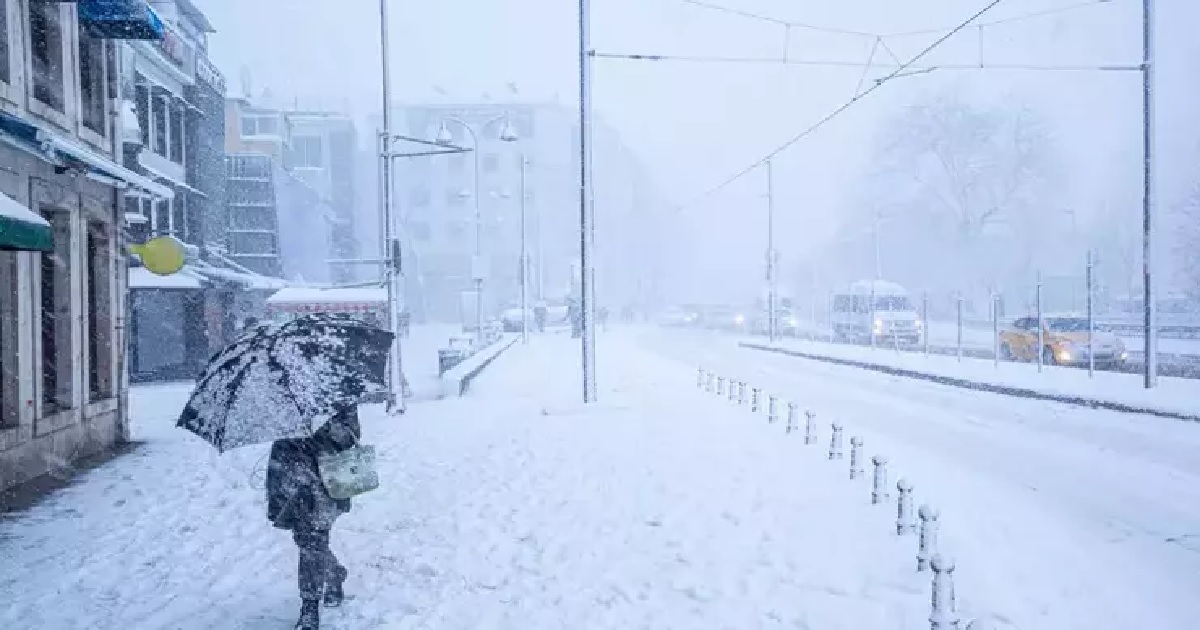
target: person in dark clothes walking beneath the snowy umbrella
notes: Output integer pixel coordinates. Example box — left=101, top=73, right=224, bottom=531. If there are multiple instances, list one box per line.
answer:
left=266, top=403, right=361, bottom=630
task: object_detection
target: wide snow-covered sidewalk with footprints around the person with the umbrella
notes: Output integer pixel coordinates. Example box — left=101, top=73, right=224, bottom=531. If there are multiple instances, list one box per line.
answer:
left=7, top=334, right=945, bottom=630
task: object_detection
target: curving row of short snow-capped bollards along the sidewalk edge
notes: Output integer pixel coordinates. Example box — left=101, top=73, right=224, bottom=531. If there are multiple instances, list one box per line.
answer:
left=696, top=367, right=992, bottom=630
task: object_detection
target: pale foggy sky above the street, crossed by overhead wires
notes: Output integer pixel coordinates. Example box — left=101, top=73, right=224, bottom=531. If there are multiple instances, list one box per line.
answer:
left=197, top=0, right=1200, bottom=300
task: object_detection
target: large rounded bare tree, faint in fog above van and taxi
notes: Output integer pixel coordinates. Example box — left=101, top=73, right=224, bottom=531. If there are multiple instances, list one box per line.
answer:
left=871, top=95, right=1055, bottom=297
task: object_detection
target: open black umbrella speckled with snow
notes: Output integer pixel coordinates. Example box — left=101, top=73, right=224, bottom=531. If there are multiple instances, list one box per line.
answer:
left=178, top=314, right=392, bottom=451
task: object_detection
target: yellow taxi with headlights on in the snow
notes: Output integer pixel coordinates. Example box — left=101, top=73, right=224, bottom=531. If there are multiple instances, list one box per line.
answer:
left=1000, top=314, right=1129, bottom=367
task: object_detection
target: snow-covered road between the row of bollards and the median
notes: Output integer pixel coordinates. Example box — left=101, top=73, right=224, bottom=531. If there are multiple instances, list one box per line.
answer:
left=642, top=330, right=1200, bottom=630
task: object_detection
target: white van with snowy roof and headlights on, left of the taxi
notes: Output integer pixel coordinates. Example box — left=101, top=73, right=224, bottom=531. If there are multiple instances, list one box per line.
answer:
left=833, top=280, right=924, bottom=346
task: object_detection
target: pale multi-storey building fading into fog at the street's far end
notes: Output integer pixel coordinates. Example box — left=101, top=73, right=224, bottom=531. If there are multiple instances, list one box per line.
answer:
left=379, top=103, right=664, bottom=322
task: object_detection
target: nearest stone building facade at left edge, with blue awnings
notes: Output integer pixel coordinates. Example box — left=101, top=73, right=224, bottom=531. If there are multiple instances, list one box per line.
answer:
left=0, top=0, right=173, bottom=490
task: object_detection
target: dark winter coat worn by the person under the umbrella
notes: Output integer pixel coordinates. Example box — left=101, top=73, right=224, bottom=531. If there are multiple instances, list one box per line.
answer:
left=266, top=406, right=362, bottom=529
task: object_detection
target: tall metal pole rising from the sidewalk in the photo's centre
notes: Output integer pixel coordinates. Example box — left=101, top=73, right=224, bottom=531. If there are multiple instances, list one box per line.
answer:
left=578, top=0, right=596, bottom=403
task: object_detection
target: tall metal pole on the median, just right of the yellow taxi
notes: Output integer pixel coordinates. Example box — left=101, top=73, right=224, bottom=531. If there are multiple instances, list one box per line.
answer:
left=1141, top=0, right=1158, bottom=389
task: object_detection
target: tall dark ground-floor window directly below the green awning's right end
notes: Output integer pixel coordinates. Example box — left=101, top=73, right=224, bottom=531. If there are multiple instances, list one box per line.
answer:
left=35, top=208, right=74, bottom=414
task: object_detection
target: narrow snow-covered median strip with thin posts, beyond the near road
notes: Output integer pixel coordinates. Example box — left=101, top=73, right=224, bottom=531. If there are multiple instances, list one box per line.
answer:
left=745, top=338, right=1200, bottom=418
